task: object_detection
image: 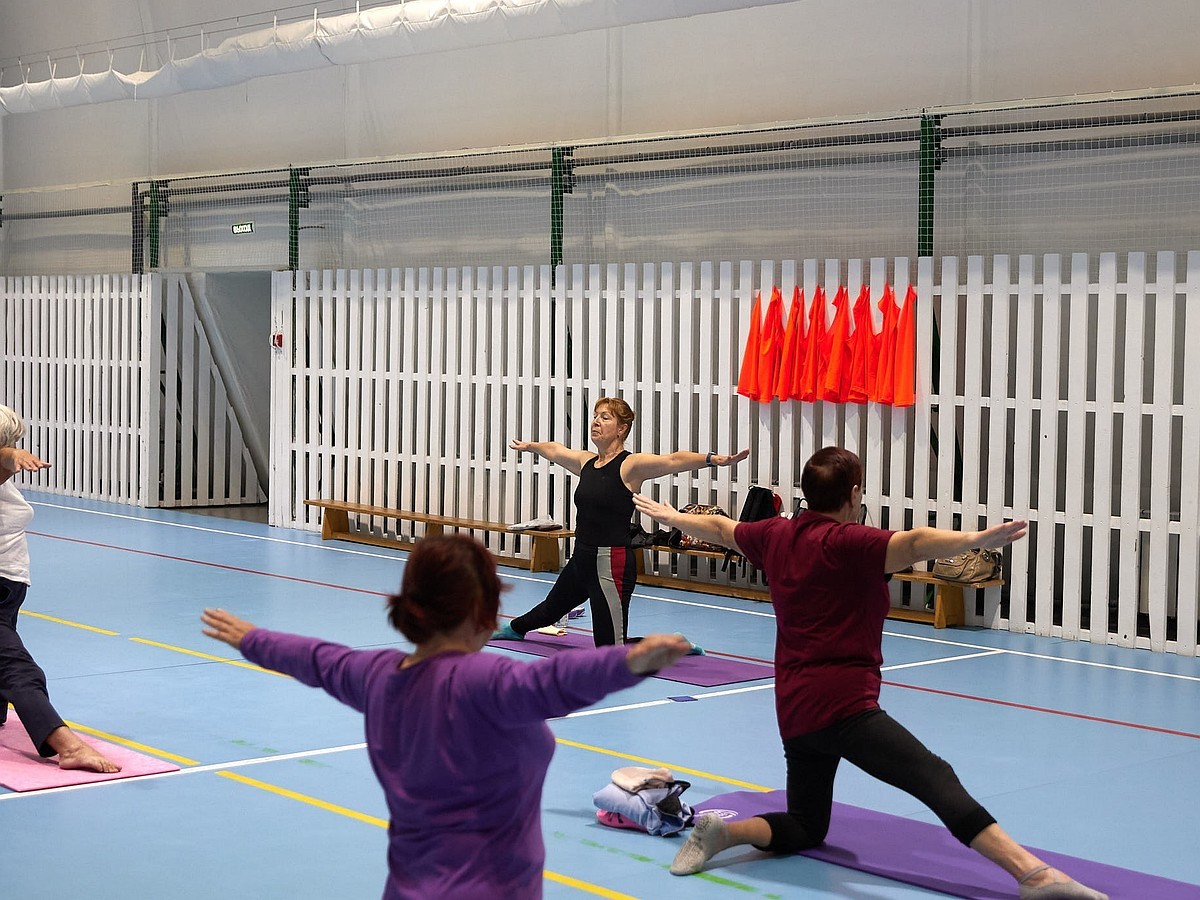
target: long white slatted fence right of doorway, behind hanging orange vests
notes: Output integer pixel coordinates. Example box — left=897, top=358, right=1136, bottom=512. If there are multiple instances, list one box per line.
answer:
left=270, top=253, right=1200, bottom=654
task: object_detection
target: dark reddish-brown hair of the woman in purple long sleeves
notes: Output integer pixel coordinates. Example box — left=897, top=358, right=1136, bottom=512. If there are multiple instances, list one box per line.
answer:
left=388, top=534, right=506, bottom=643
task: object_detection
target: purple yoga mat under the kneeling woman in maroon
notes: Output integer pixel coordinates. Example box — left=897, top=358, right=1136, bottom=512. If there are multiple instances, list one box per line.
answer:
left=695, top=791, right=1200, bottom=900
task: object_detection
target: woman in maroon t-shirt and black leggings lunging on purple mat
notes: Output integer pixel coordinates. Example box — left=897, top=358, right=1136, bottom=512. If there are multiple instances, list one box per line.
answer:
left=634, top=446, right=1106, bottom=900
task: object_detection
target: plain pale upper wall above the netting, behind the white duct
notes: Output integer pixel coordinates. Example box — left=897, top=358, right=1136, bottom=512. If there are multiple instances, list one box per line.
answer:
left=0, top=0, right=1200, bottom=190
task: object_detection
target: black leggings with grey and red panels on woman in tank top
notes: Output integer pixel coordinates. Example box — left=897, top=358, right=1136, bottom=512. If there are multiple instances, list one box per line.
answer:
left=512, top=544, right=637, bottom=647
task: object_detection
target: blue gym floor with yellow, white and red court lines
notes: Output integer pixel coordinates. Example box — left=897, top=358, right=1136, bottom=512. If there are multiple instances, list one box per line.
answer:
left=0, top=492, right=1200, bottom=900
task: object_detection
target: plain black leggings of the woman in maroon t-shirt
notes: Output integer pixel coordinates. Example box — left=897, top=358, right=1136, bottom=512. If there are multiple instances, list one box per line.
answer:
left=760, top=709, right=996, bottom=853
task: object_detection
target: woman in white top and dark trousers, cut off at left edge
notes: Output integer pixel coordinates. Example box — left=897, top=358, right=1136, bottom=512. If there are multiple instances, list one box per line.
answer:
left=0, top=406, right=121, bottom=772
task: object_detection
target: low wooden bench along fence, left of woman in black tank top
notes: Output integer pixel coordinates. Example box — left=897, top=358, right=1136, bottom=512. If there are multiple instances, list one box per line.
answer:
left=305, top=500, right=575, bottom=572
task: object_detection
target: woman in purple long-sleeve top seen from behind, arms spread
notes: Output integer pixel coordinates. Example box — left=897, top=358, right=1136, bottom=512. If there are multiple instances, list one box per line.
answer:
left=202, top=535, right=689, bottom=900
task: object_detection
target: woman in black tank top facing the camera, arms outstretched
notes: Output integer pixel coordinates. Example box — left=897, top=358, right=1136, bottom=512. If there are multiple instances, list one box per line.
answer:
left=494, top=397, right=750, bottom=653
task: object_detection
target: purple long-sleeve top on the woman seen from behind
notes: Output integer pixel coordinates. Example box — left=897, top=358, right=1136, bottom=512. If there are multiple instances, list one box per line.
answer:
left=241, top=629, right=640, bottom=900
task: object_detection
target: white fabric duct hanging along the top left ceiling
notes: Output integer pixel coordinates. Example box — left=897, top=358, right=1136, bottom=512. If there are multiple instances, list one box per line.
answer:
left=0, top=0, right=792, bottom=114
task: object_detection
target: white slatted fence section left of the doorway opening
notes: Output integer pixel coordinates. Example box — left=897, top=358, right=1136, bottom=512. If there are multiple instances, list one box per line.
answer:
left=0, top=275, right=263, bottom=506
